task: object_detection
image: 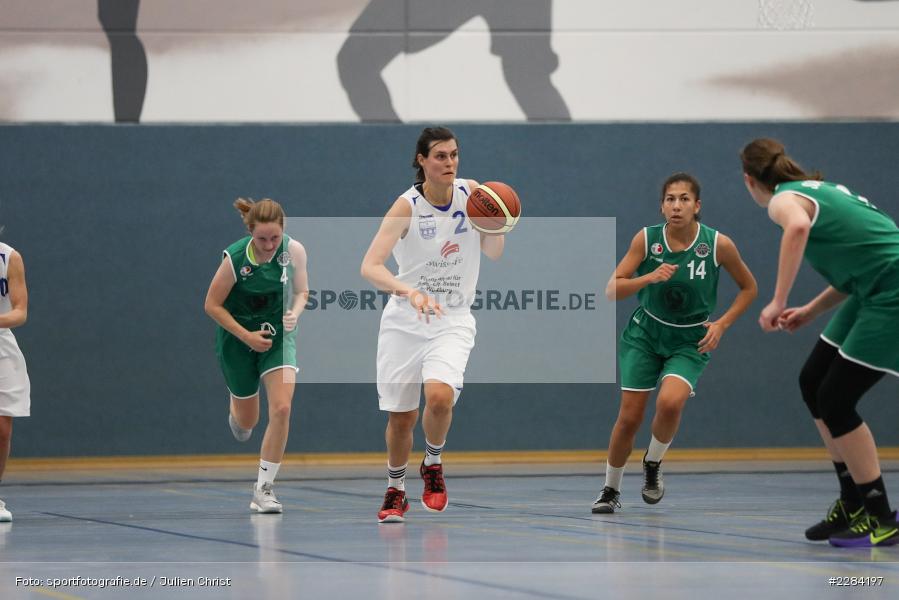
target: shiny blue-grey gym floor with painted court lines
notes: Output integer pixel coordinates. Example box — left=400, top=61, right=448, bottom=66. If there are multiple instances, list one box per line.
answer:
left=0, top=455, right=899, bottom=600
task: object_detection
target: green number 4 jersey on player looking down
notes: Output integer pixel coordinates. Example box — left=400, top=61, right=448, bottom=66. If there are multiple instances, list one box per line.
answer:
left=224, top=235, right=294, bottom=331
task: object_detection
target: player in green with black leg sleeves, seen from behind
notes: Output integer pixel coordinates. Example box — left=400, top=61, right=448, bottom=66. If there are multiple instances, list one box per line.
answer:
left=740, top=138, right=899, bottom=546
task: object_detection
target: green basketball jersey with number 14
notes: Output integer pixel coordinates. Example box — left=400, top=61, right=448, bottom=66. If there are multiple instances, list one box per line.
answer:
left=637, top=223, right=718, bottom=326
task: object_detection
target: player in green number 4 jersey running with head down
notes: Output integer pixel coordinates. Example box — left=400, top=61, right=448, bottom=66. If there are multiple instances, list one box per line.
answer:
left=205, top=198, right=309, bottom=513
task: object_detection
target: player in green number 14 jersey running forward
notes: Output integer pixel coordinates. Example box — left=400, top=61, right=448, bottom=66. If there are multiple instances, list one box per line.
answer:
left=593, top=173, right=757, bottom=513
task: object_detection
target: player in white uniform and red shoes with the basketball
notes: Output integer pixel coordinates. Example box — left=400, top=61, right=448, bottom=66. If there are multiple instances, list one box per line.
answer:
left=362, top=127, right=505, bottom=523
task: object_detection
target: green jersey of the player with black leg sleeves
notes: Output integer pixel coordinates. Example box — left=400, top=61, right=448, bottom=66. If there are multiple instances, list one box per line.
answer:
left=774, top=181, right=899, bottom=296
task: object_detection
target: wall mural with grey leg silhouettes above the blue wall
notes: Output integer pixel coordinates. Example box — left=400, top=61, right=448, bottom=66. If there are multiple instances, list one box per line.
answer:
left=0, top=0, right=899, bottom=122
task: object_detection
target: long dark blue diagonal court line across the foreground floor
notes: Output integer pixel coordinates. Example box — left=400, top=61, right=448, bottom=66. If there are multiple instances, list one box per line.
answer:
left=38, top=512, right=590, bottom=600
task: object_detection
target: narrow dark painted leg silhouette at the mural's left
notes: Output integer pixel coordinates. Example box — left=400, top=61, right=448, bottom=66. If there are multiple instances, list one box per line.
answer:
left=97, top=0, right=147, bottom=123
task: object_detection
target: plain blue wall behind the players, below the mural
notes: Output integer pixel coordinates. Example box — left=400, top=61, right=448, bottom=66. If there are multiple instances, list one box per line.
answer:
left=0, top=123, right=899, bottom=456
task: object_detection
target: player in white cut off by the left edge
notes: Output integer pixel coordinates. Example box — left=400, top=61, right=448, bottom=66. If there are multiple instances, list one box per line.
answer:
left=0, top=242, right=31, bottom=523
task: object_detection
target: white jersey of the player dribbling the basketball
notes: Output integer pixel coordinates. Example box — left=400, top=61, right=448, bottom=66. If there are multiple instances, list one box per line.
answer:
left=393, top=179, right=481, bottom=314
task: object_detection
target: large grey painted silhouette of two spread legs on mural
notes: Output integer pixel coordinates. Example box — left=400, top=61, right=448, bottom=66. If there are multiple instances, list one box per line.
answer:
left=337, top=0, right=571, bottom=121
